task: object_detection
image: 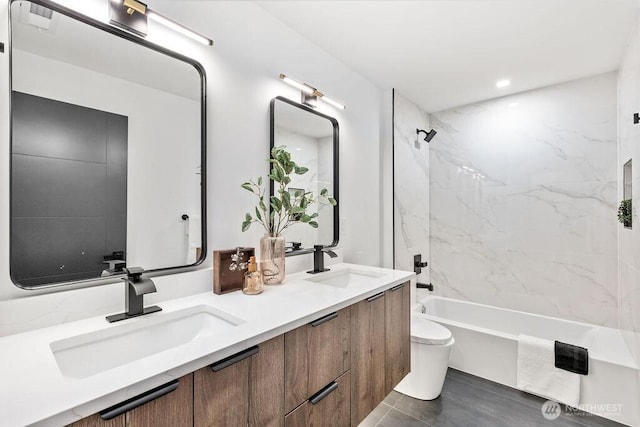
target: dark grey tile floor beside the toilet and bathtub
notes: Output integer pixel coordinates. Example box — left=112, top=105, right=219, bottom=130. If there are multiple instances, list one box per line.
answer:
left=360, top=369, right=622, bottom=427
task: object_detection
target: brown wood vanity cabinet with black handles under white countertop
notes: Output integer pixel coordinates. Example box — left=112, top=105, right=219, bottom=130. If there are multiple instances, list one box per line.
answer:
left=62, top=282, right=411, bottom=427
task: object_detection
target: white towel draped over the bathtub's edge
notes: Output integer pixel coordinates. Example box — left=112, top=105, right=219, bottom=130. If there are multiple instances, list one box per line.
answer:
left=517, top=335, right=580, bottom=407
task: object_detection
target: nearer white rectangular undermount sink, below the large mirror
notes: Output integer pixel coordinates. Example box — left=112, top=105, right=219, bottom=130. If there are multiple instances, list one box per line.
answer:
left=50, top=305, right=245, bottom=378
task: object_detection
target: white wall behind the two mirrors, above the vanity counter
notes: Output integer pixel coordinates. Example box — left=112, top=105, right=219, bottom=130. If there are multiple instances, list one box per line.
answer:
left=0, top=0, right=382, bottom=335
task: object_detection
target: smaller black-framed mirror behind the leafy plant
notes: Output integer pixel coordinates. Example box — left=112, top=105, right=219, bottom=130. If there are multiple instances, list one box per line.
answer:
left=270, top=96, right=340, bottom=256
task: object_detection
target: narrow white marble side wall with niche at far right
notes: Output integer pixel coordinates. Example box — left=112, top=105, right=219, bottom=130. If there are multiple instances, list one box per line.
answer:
left=616, top=13, right=640, bottom=362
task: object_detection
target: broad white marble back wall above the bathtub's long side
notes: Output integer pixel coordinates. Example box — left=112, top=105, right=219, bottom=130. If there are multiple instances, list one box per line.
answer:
left=430, top=73, right=618, bottom=327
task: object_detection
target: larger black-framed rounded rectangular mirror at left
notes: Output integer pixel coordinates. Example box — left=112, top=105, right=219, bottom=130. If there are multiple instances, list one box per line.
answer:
left=10, top=0, right=206, bottom=289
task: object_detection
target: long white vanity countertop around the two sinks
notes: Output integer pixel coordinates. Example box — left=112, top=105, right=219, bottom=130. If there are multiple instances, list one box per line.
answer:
left=0, top=264, right=415, bottom=426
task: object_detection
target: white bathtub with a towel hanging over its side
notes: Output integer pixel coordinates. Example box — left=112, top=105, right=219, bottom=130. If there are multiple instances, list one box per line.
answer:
left=416, top=296, right=640, bottom=426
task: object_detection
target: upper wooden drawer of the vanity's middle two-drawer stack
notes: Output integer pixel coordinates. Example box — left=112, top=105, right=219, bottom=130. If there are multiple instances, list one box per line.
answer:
left=284, top=307, right=351, bottom=412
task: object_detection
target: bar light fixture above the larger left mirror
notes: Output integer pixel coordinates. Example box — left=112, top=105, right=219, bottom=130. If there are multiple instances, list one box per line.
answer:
left=110, top=0, right=213, bottom=46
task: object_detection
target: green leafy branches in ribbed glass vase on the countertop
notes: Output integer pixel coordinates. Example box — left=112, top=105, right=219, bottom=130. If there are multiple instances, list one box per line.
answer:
left=242, top=146, right=337, bottom=285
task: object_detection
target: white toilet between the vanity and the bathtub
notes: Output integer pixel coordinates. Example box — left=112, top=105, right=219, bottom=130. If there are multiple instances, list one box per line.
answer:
left=395, top=311, right=455, bottom=400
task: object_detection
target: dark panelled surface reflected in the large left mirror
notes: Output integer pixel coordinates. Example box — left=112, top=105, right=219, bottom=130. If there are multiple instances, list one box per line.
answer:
left=11, top=91, right=128, bottom=286
